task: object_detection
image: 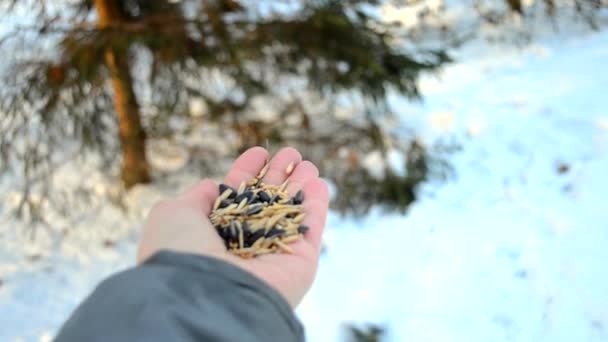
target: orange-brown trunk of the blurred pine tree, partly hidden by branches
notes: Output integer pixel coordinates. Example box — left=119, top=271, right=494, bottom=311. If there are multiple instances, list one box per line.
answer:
left=95, top=0, right=150, bottom=188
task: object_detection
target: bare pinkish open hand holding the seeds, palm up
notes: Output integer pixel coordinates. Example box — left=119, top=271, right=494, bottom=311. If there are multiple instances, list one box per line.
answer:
left=137, top=147, right=329, bottom=307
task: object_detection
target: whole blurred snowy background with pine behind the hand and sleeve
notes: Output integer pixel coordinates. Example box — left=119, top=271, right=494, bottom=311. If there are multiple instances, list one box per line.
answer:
left=0, top=0, right=608, bottom=342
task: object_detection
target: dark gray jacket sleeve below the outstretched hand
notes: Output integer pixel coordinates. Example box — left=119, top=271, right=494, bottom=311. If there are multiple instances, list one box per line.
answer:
left=56, top=251, right=304, bottom=342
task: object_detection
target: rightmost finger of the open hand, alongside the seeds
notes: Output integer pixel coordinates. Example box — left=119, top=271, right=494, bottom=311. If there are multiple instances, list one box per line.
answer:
left=302, top=178, right=329, bottom=251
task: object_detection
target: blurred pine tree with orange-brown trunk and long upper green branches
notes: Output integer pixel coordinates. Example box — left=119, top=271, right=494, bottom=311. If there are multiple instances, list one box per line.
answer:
left=0, top=0, right=447, bottom=187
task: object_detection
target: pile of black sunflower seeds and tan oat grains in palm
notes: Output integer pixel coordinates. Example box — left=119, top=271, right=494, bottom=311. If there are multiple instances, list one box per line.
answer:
left=209, top=163, right=308, bottom=258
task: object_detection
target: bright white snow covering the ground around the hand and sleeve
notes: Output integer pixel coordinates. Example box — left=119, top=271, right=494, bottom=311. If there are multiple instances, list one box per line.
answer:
left=0, top=26, right=608, bottom=342
